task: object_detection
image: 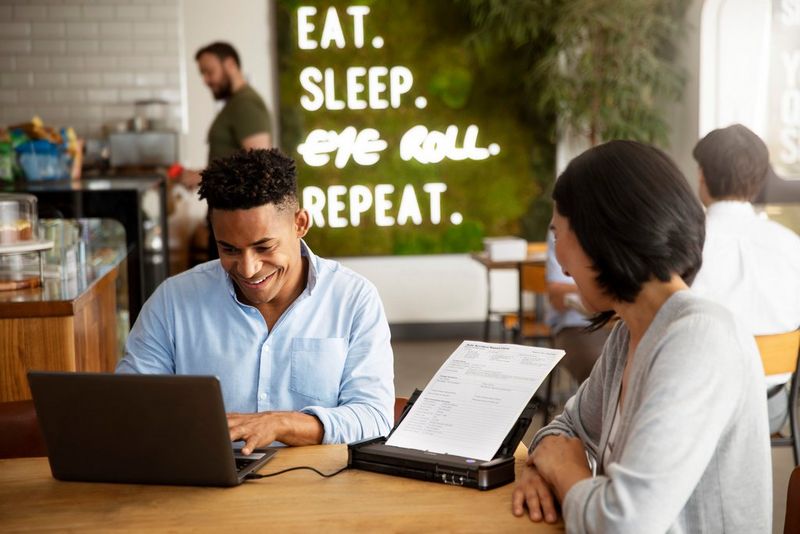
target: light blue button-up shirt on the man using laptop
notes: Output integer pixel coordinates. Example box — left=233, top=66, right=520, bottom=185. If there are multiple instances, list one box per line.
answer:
left=117, top=243, right=394, bottom=443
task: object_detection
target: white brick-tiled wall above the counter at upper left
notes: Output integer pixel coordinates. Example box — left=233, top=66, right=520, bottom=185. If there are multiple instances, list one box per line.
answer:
left=0, top=0, right=181, bottom=137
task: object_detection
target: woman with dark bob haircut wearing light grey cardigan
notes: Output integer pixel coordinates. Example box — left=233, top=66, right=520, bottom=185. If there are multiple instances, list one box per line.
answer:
left=512, top=141, right=772, bottom=533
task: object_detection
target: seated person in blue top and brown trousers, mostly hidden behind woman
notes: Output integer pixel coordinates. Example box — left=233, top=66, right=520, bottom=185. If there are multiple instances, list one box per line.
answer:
left=545, top=232, right=609, bottom=383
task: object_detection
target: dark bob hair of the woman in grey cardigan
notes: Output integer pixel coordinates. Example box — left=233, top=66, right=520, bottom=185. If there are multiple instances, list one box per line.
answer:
left=553, top=141, right=705, bottom=330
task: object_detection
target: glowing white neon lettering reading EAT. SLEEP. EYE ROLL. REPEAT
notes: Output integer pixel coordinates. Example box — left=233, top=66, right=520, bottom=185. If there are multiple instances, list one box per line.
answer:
left=290, top=6, right=500, bottom=228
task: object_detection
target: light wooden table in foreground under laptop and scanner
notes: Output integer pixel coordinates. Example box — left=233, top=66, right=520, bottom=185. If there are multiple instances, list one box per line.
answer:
left=0, top=446, right=563, bottom=533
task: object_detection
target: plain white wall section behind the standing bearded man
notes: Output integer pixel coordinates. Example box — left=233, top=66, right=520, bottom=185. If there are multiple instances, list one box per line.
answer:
left=180, top=0, right=278, bottom=168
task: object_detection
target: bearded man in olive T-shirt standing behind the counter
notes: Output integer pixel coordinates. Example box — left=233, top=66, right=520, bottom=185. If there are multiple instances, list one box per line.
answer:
left=182, top=42, right=272, bottom=259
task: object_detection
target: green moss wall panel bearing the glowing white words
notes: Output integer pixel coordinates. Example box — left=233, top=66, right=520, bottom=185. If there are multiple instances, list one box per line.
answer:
left=278, top=0, right=552, bottom=256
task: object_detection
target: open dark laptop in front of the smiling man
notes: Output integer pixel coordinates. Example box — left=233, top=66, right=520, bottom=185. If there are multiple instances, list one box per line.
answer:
left=28, top=371, right=276, bottom=486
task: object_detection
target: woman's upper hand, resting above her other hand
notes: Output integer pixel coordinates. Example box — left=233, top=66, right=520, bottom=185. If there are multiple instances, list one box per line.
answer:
left=528, top=435, right=592, bottom=502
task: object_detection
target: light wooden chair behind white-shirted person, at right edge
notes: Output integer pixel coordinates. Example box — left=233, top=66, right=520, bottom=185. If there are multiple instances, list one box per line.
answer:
left=756, top=330, right=800, bottom=465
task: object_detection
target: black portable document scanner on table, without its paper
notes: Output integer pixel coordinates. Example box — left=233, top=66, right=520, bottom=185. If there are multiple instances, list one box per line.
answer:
left=347, top=389, right=537, bottom=490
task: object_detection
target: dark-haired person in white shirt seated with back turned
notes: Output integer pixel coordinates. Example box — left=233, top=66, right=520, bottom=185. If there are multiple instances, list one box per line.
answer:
left=692, top=124, right=800, bottom=433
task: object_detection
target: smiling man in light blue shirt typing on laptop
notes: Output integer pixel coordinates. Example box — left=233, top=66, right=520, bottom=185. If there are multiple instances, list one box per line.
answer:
left=117, top=149, right=394, bottom=454
